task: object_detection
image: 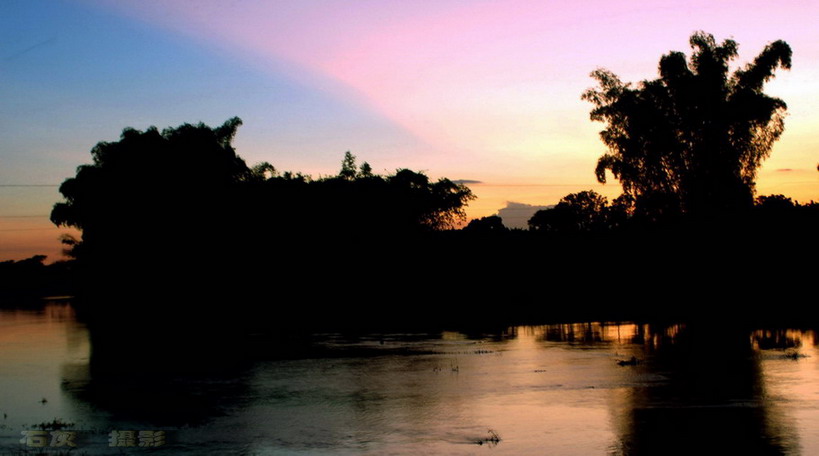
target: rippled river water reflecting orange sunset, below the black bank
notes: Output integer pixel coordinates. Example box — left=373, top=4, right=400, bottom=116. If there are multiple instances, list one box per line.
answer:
left=0, top=305, right=819, bottom=455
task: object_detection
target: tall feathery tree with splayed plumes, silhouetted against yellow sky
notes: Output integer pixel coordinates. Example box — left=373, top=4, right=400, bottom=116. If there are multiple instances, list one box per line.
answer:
left=582, top=32, right=791, bottom=218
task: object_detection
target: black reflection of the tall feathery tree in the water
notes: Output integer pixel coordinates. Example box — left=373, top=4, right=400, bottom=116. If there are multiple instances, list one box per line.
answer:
left=615, top=326, right=796, bottom=455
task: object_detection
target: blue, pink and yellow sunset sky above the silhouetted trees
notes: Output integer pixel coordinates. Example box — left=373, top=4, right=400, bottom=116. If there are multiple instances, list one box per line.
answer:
left=0, top=0, right=819, bottom=261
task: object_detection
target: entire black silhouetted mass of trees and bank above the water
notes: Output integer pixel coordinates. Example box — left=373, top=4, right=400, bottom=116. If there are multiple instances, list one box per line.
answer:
left=0, top=32, right=819, bottom=337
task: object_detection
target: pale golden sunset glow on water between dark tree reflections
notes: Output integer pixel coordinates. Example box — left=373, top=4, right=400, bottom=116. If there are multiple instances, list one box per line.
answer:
left=240, top=327, right=623, bottom=455
